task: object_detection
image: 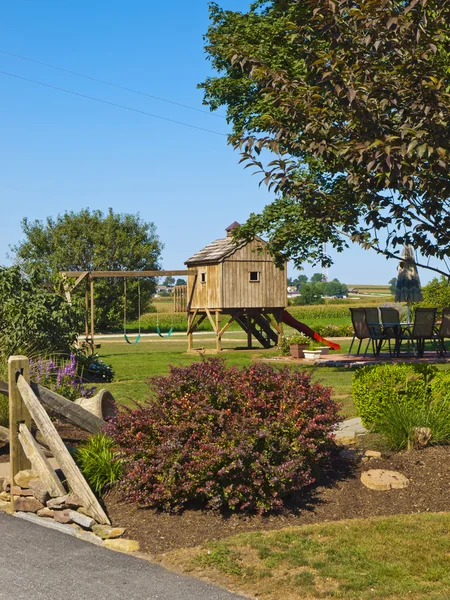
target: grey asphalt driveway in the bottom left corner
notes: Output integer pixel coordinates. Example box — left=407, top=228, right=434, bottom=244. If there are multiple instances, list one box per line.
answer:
left=0, top=512, right=243, bottom=600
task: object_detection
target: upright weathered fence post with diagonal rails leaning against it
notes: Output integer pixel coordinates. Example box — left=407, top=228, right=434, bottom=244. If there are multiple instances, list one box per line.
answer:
left=8, top=356, right=31, bottom=500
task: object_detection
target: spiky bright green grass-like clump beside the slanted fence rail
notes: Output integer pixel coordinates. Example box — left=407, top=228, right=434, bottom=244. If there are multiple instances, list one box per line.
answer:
left=75, top=433, right=122, bottom=494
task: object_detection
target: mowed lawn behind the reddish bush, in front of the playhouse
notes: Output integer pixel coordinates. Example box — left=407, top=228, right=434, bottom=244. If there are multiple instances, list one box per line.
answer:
left=98, top=332, right=355, bottom=417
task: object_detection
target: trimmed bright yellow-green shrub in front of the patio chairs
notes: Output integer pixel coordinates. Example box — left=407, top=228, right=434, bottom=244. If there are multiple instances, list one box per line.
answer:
left=352, top=363, right=437, bottom=428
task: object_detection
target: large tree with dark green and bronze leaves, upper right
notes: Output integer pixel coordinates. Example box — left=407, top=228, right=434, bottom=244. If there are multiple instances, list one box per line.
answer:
left=201, top=0, right=450, bottom=274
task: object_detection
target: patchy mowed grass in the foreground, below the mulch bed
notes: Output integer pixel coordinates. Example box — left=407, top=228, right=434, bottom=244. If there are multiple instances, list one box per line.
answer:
left=162, top=513, right=450, bottom=600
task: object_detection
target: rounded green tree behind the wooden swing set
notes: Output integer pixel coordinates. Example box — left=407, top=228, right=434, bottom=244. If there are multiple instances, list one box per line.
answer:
left=12, top=208, right=163, bottom=329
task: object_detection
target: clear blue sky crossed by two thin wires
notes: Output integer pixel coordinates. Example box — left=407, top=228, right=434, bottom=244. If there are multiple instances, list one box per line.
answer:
left=0, top=0, right=442, bottom=284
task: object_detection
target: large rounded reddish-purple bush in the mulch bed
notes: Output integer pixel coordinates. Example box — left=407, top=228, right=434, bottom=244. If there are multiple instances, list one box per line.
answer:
left=107, top=358, right=337, bottom=513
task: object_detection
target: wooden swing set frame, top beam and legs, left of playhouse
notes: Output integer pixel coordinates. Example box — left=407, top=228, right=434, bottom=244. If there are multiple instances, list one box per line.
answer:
left=59, top=269, right=192, bottom=350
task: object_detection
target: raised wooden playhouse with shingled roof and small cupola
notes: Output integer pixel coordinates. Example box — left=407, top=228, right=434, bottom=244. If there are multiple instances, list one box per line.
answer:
left=185, top=222, right=287, bottom=351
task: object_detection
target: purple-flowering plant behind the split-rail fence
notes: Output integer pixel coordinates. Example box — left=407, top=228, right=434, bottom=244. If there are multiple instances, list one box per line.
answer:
left=30, top=354, right=97, bottom=400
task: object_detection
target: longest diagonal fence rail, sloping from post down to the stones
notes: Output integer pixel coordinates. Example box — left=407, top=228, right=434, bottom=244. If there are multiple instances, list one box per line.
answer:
left=17, top=375, right=111, bottom=525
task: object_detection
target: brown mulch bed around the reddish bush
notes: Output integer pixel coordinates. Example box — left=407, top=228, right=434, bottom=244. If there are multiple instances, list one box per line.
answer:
left=0, top=423, right=450, bottom=555
